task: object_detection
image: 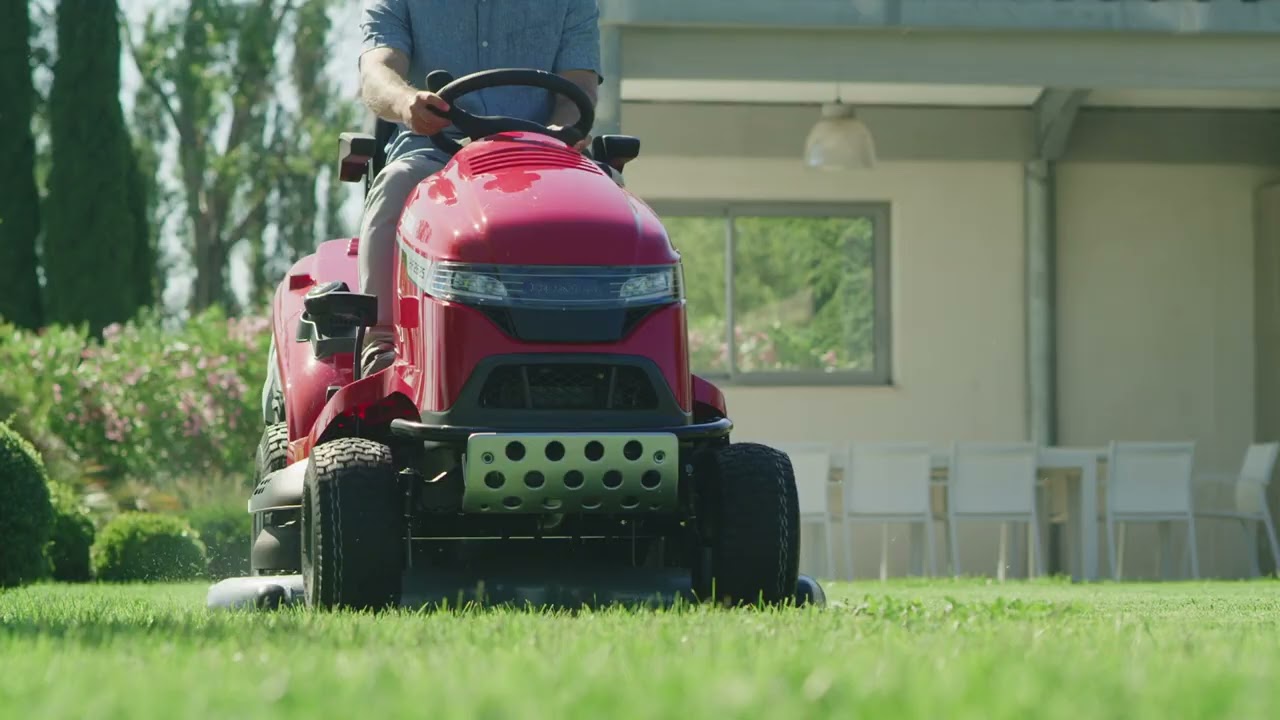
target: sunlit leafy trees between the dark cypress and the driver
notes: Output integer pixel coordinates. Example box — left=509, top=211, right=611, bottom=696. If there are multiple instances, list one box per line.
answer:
left=132, top=0, right=353, bottom=311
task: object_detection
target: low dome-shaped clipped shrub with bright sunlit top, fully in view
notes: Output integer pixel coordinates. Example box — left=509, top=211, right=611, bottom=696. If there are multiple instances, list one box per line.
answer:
left=92, top=512, right=205, bottom=583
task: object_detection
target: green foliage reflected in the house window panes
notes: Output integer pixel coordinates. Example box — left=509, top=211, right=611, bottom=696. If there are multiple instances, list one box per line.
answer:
left=664, top=215, right=876, bottom=373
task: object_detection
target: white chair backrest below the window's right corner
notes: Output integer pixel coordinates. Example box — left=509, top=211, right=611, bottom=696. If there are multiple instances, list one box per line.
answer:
left=844, top=442, right=933, bottom=516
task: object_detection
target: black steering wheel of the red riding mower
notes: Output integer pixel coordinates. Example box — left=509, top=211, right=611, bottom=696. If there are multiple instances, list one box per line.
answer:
left=426, top=68, right=595, bottom=156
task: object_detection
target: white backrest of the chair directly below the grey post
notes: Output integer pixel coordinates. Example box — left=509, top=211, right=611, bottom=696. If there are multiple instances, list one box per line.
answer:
left=947, top=442, right=1038, bottom=515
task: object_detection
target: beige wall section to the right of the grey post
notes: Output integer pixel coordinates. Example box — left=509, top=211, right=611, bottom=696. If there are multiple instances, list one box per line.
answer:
left=1059, top=163, right=1272, bottom=577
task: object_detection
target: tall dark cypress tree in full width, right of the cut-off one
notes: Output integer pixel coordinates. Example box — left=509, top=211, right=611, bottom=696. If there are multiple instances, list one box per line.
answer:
left=44, top=0, right=152, bottom=333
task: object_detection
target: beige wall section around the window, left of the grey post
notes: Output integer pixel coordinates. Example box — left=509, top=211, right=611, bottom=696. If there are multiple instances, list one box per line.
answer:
left=627, top=158, right=1025, bottom=442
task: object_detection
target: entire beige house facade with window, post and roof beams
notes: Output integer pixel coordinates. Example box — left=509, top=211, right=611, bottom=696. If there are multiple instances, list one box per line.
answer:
left=600, top=0, right=1280, bottom=577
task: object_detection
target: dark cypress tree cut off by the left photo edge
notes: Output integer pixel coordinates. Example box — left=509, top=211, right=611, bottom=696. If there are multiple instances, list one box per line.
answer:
left=0, top=0, right=42, bottom=328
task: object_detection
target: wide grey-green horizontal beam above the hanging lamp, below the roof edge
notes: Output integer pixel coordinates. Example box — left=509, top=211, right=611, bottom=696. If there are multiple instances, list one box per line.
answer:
left=622, top=27, right=1280, bottom=90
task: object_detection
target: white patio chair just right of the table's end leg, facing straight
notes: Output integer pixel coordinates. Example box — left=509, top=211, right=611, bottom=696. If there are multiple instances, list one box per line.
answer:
left=1106, top=442, right=1199, bottom=580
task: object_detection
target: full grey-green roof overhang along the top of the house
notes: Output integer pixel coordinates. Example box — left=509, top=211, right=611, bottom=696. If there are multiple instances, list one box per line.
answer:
left=600, top=0, right=1280, bottom=95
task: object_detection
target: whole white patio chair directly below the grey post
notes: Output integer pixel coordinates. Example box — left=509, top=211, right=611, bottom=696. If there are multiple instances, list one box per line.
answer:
left=947, top=442, right=1044, bottom=582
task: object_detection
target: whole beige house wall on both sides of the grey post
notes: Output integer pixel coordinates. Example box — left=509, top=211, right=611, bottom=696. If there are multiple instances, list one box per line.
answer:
left=623, top=106, right=1280, bottom=577
